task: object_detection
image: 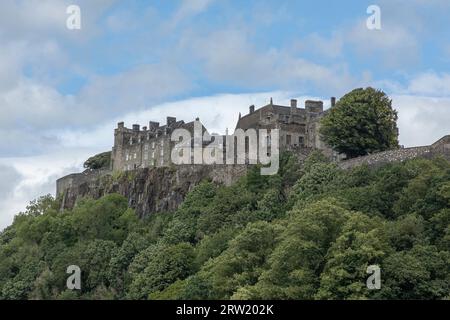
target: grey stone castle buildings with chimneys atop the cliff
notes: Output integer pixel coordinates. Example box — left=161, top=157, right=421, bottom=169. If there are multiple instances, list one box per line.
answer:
left=111, top=97, right=338, bottom=171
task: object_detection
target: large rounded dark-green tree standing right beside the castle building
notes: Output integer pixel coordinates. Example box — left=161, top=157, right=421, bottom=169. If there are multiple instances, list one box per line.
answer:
left=320, top=87, right=398, bottom=158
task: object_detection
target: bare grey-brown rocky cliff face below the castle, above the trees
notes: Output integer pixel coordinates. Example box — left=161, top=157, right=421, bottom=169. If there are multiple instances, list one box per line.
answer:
left=57, top=165, right=247, bottom=217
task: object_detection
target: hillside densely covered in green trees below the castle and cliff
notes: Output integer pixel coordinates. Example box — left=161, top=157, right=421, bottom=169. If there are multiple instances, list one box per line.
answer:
left=0, top=153, right=450, bottom=299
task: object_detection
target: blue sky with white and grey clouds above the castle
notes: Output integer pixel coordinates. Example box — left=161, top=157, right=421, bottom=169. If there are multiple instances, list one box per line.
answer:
left=0, top=0, right=450, bottom=230
